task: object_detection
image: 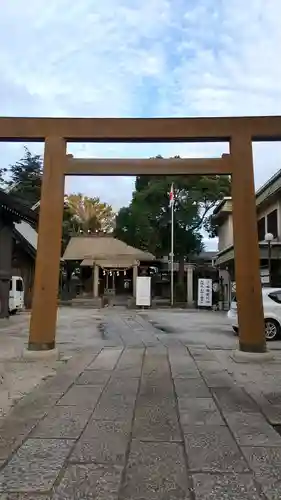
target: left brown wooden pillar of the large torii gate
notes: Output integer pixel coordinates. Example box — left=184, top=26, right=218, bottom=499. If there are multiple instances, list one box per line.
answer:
left=28, top=136, right=66, bottom=351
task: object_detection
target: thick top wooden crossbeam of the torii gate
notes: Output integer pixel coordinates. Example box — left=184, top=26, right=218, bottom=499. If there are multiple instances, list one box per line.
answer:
left=0, top=116, right=281, bottom=142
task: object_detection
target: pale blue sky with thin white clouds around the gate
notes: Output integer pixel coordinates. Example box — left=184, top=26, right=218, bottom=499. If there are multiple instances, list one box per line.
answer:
left=0, top=0, right=281, bottom=250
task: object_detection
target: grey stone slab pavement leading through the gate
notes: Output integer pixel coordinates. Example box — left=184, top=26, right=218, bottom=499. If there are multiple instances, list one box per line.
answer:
left=0, top=311, right=281, bottom=500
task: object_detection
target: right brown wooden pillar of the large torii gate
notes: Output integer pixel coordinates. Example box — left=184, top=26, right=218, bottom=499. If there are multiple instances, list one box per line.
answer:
left=230, top=131, right=266, bottom=353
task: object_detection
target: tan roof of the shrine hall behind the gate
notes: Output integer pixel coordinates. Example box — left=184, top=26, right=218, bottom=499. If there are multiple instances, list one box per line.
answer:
left=63, top=235, right=155, bottom=267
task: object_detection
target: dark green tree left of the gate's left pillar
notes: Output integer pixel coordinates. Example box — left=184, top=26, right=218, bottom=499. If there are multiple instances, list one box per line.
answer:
left=7, top=147, right=43, bottom=206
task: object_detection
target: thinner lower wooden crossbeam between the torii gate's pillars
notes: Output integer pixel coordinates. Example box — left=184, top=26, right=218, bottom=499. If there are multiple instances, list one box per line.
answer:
left=64, top=155, right=232, bottom=176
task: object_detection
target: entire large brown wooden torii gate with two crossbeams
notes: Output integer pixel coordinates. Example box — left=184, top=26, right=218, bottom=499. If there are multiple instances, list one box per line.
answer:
left=0, top=116, right=281, bottom=353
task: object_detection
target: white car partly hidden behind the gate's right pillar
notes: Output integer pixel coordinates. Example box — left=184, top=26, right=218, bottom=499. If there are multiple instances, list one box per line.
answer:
left=227, top=288, right=281, bottom=340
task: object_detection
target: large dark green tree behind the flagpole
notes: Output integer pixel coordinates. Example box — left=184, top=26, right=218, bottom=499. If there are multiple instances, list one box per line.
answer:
left=115, top=158, right=230, bottom=260
